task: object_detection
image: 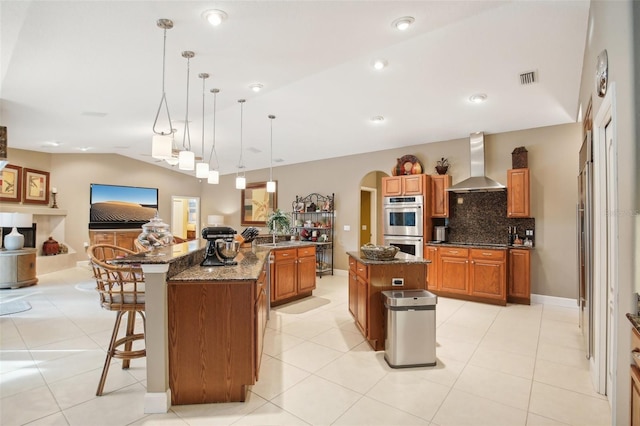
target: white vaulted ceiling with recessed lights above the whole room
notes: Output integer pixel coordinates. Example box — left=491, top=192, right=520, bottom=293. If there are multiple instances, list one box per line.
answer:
left=0, top=0, right=589, bottom=174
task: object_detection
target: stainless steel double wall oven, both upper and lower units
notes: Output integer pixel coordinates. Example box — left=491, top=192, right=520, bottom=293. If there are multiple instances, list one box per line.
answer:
left=383, top=195, right=424, bottom=257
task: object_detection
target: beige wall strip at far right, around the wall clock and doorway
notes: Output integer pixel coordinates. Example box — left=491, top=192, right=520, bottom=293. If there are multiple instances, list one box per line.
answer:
left=580, top=0, right=640, bottom=425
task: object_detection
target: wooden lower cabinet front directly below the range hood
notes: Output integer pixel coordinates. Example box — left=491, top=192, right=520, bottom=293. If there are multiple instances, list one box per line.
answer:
left=469, top=250, right=506, bottom=300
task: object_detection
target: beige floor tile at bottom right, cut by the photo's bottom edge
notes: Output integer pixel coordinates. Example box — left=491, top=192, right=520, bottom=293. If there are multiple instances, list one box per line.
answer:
left=529, top=381, right=611, bottom=426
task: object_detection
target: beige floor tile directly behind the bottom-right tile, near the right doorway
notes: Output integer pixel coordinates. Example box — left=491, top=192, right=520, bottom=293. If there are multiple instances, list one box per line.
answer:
left=533, top=359, right=606, bottom=399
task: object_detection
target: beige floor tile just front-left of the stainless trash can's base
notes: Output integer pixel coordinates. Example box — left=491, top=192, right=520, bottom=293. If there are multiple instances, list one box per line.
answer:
left=315, top=352, right=387, bottom=394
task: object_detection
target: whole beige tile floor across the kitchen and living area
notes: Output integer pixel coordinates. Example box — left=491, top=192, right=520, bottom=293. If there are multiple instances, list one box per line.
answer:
left=0, top=268, right=611, bottom=426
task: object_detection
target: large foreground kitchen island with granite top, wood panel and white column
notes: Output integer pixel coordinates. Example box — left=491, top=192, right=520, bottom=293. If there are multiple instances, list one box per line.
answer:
left=114, top=240, right=270, bottom=413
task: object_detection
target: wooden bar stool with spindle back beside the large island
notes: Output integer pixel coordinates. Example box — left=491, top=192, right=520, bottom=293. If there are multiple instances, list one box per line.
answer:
left=87, top=244, right=147, bottom=396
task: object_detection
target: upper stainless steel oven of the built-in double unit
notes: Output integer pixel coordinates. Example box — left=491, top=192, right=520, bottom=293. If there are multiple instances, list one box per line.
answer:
left=383, top=195, right=424, bottom=237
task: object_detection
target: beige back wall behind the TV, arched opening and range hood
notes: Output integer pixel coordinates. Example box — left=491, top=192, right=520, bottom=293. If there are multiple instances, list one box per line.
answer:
left=9, top=120, right=581, bottom=298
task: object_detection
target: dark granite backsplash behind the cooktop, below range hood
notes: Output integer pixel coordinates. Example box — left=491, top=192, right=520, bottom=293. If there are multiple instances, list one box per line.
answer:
left=448, top=191, right=536, bottom=244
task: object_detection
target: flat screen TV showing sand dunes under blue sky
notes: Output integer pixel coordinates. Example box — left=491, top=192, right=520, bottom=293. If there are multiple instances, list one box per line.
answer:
left=89, top=183, right=158, bottom=229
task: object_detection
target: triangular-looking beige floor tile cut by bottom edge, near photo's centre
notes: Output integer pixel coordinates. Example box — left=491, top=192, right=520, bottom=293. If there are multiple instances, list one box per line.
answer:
left=333, top=396, right=429, bottom=426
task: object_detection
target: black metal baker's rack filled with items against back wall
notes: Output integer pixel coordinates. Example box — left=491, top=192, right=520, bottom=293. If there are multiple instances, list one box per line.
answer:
left=291, top=192, right=335, bottom=278
